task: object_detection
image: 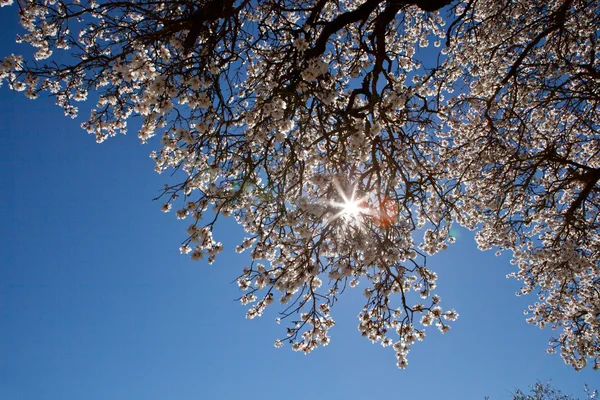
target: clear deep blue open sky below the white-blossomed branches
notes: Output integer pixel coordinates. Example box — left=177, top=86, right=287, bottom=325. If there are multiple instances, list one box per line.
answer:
left=0, top=3, right=600, bottom=400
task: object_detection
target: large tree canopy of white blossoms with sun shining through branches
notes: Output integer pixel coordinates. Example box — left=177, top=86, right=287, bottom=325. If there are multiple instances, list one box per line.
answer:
left=0, top=0, right=600, bottom=369
